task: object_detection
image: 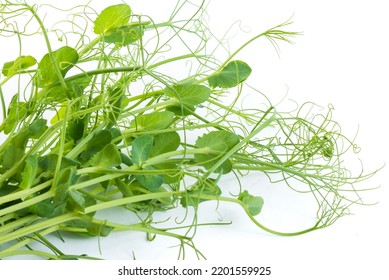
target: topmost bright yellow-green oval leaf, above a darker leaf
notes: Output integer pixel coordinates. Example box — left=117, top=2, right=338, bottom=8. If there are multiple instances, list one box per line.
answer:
left=93, top=4, right=131, bottom=35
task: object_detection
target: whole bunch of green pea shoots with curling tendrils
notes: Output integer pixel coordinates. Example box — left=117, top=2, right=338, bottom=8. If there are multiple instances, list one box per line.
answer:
left=0, top=0, right=374, bottom=259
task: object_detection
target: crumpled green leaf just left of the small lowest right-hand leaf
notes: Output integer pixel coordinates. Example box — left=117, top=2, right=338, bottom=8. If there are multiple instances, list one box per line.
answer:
left=181, top=178, right=222, bottom=207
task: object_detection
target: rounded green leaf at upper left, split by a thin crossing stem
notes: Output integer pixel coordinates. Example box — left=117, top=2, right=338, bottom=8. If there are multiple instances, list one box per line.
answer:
left=37, top=46, right=78, bottom=87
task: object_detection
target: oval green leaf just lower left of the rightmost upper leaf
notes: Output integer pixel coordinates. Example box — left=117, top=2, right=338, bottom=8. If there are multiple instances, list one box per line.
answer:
left=163, top=84, right=211, bottom=107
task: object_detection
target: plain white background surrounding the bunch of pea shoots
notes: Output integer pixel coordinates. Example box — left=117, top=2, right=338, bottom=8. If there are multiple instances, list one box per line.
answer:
left=0, top=0, right=389, bottom=279
